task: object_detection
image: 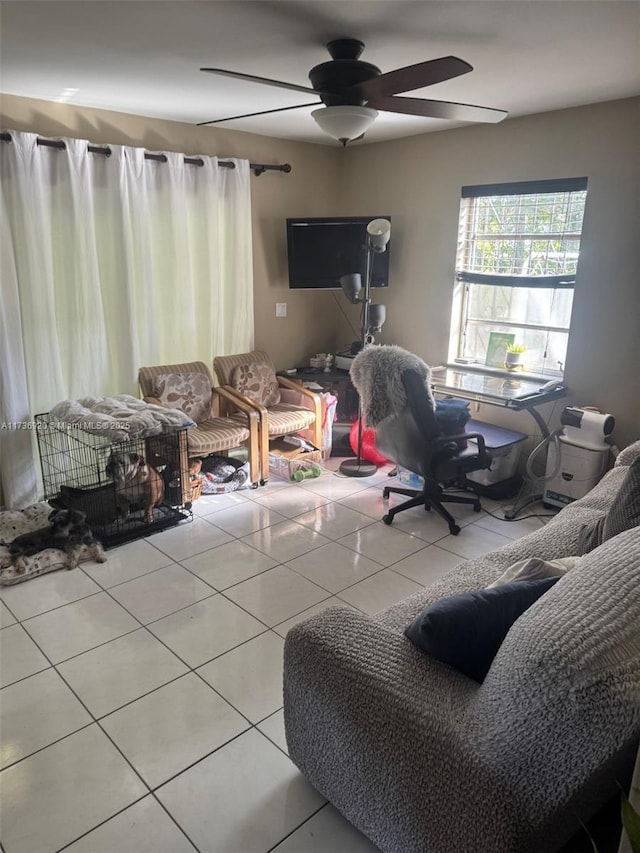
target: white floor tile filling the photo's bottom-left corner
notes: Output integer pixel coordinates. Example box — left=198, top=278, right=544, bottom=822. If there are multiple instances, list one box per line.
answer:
left=0, top=724, right=146, bottom=853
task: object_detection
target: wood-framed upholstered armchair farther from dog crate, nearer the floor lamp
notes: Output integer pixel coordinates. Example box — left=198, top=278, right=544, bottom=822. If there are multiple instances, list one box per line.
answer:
left=213, top=350, right=322, bottom=483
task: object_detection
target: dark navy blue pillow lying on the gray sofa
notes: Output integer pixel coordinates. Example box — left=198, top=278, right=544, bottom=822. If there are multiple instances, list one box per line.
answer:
left=404, top=578, right=559, bottom=682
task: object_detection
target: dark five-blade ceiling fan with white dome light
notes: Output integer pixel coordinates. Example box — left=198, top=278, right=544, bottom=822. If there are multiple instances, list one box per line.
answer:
left=199, top=38, right=507, bottom=145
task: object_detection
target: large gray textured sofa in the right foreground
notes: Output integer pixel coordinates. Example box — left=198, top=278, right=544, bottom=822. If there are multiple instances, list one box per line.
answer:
left=284, top=442, right=640, bottom=853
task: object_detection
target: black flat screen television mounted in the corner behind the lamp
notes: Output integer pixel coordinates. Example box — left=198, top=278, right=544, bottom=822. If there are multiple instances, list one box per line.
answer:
left=287, top=216, right=391, bottom=290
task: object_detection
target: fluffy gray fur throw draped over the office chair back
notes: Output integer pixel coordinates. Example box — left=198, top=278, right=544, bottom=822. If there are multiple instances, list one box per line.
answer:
left=349, top=345, right=435, bottom=428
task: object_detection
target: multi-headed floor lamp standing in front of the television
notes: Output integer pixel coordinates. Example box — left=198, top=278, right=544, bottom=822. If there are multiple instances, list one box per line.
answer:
left=340, top=219, right=391, bottom=477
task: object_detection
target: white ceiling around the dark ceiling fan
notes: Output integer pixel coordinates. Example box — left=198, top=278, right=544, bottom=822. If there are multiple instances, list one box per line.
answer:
left=0, top=0, right=640, bottom=145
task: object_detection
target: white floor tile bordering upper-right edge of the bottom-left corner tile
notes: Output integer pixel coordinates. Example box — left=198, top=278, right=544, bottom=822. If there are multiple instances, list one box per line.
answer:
left=101, top=672, right=249, bottom=788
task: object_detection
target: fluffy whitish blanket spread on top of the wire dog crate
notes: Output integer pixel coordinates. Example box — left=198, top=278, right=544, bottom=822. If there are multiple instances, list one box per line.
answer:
left=49, top=394, right=195, bottom=443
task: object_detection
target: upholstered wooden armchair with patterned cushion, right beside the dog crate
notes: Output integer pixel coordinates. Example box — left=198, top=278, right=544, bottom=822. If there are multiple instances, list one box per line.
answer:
left=138, top=361, right=260, bottom=488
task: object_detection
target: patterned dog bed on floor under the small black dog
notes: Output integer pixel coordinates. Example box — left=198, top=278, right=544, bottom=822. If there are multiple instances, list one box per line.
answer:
left=0, top=502, right=102, bottom=586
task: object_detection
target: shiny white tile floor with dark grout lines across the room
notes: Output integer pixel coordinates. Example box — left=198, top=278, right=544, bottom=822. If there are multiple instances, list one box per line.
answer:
left=0, top=459, right=543, bottom=853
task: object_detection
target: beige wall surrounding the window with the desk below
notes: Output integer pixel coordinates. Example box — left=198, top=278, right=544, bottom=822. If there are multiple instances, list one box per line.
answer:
left=338, top=98, right=640, bottom=445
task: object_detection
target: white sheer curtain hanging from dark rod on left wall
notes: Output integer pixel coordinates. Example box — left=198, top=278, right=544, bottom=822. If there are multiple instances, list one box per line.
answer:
left=0, top=131, right=253, bottom=507
